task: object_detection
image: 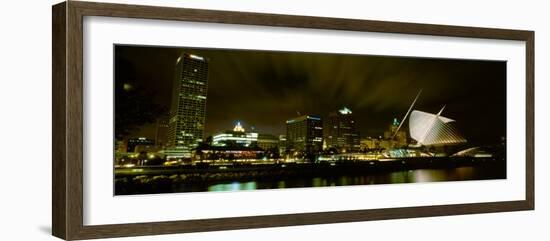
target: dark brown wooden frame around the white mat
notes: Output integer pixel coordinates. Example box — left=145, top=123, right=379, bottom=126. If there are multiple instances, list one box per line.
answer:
left=52, top=1, right=535, bottom=240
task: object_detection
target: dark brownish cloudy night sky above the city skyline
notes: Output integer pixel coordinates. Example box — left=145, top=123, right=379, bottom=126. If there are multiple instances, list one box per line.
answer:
left=115, top=46, right=506, bottom=144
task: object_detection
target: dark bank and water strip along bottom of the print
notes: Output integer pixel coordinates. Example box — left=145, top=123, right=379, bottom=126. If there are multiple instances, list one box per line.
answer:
left=115, top=157, right=506, bottom=195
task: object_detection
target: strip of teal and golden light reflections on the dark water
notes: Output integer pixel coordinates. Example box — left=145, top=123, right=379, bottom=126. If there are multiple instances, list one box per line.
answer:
left=207, top=167, right=492, bottom=192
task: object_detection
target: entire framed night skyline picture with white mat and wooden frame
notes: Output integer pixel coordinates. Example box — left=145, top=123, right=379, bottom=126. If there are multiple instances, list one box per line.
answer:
left=52, top=1, right=534, bottom=240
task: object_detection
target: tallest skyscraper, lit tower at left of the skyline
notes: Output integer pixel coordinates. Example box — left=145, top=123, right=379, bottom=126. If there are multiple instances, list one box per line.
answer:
left=167, top=53, right=208, bottom=157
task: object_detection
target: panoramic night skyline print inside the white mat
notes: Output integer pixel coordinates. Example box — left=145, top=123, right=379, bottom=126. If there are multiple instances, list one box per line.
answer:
left=112, top=45, right=506, bottom=195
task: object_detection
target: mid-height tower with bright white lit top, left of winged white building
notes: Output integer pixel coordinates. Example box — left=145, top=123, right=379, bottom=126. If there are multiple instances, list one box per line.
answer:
left=324, top=107, right=361, bottom=152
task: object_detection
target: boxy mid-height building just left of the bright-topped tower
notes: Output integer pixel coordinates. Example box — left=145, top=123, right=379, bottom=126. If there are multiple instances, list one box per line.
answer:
left=286, top=115, right=323, bottom=153
